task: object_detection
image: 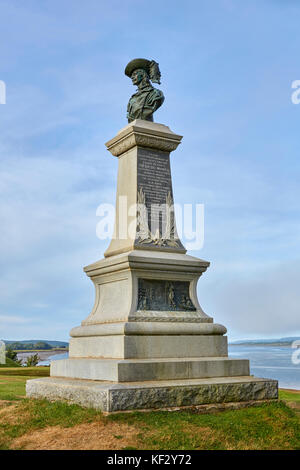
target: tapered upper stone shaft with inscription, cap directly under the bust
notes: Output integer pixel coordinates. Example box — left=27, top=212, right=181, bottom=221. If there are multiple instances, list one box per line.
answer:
left=104, top=119, right=186, bottom=257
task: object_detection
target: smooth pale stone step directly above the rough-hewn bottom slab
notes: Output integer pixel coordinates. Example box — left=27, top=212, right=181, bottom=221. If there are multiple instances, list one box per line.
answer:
left=51, top=357, right=250, bottom=382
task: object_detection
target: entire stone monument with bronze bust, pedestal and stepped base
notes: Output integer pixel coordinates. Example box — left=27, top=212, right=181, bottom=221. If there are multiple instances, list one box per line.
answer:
left=26, top=59, right=278, bottom=412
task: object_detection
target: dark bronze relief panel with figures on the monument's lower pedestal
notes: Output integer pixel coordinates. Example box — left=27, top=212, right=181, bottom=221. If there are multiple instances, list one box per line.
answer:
left=137, top=279, right=196, bottom=311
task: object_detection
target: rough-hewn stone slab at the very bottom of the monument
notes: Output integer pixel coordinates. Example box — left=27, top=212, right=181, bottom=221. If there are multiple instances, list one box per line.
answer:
left=26, top=376, right=278, bottom=412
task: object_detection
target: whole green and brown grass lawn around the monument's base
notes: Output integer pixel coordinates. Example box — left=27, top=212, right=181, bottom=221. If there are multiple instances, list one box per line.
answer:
left=0, top=368, right=300, bottom=450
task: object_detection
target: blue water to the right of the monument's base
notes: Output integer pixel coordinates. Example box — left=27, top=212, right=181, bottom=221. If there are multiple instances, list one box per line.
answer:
left=228, top=345, right=300, bottom=390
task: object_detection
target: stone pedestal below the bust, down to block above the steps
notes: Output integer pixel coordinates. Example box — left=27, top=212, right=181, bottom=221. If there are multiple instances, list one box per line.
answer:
left=66, top=120, right=227, bottom=359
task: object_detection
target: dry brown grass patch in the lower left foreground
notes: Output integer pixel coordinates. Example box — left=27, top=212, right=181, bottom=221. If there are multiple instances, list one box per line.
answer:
left=10, top=421, right=138, bottom=450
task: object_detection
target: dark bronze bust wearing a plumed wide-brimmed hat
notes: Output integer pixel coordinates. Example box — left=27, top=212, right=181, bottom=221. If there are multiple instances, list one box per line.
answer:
left=125, top=59, right=165, bottom=122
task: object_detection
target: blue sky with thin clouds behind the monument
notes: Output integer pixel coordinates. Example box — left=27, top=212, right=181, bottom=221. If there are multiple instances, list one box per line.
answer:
left=0, top=0, right=300, bottom=340
